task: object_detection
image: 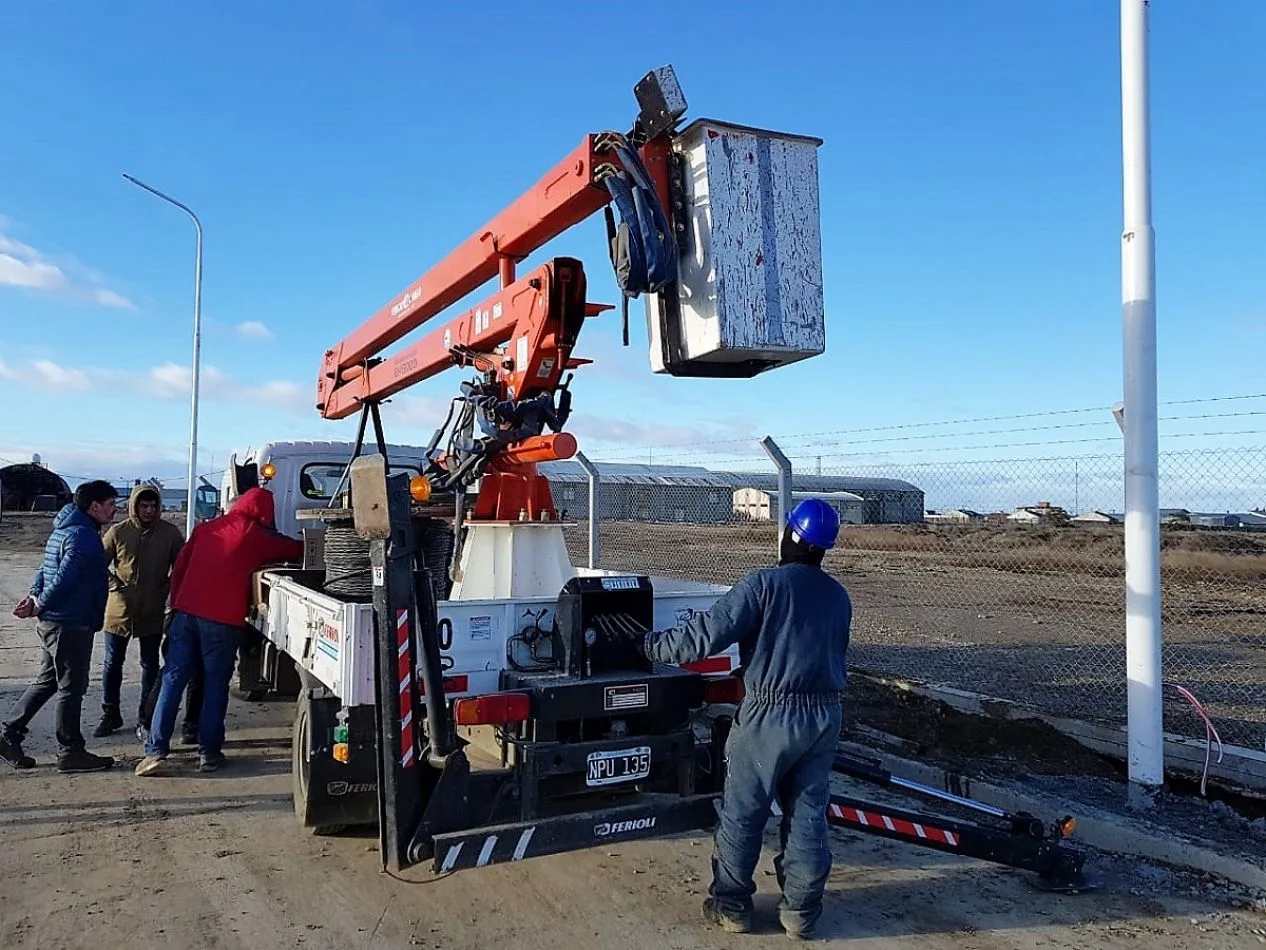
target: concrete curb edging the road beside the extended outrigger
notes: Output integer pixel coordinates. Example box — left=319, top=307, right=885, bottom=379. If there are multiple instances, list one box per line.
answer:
left=839, top=741, right=1266, bottom=890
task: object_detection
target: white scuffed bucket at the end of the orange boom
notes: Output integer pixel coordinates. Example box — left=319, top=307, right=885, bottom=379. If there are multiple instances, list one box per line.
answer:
left=644, top=119, right=827, bottom=377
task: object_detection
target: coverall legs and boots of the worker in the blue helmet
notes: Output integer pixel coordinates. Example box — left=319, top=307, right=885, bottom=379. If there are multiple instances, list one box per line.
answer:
left=709, top=698, right=843, bottom=931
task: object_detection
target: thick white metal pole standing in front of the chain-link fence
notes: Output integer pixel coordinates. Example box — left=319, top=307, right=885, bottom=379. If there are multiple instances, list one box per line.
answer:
left=1120, top=0, right=1165, bottom=808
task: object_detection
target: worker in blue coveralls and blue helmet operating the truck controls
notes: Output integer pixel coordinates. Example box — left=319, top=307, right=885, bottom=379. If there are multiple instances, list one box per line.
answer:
left=642, top=498, right=852, bottom=939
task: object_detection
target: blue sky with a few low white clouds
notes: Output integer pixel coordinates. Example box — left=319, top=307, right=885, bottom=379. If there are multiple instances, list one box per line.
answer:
left=0, top=0, right=1266, bottom=506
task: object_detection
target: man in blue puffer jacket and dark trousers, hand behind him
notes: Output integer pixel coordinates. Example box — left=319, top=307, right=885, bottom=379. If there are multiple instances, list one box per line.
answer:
left=0, top=481, right=119, bottom=771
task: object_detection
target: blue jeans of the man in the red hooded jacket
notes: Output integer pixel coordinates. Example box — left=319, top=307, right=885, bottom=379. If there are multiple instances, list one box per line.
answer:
left=146, top=612, right=242, bottom=757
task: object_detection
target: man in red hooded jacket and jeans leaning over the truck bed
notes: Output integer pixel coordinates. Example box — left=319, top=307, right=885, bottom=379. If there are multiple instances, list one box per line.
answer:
left=137, top=488, right=304, bottom=775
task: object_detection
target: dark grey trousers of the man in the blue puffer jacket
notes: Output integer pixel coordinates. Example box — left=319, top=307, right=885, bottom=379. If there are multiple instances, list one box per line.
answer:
left=4, top=621, right=94, bottom=755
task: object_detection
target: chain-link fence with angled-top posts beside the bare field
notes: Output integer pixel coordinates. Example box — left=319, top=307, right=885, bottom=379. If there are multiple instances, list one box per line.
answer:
left=570, top=445, right=1266, bottom=749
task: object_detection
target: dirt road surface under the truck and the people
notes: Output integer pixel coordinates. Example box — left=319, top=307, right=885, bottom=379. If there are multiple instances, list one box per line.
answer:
left=0, top=522, right=1266, bottom=950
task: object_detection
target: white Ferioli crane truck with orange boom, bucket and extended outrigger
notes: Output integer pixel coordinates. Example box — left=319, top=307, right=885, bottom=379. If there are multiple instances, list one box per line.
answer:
left=235, top=67, right=1089, bottom=890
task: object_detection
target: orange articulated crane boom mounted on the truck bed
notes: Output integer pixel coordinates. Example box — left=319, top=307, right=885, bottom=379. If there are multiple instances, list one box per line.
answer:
left=317, top=67, right=685, bottom=529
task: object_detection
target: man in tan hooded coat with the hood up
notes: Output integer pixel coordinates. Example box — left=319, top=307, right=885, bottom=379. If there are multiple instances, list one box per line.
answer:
left=92, top=484, right=185, bottom=737
